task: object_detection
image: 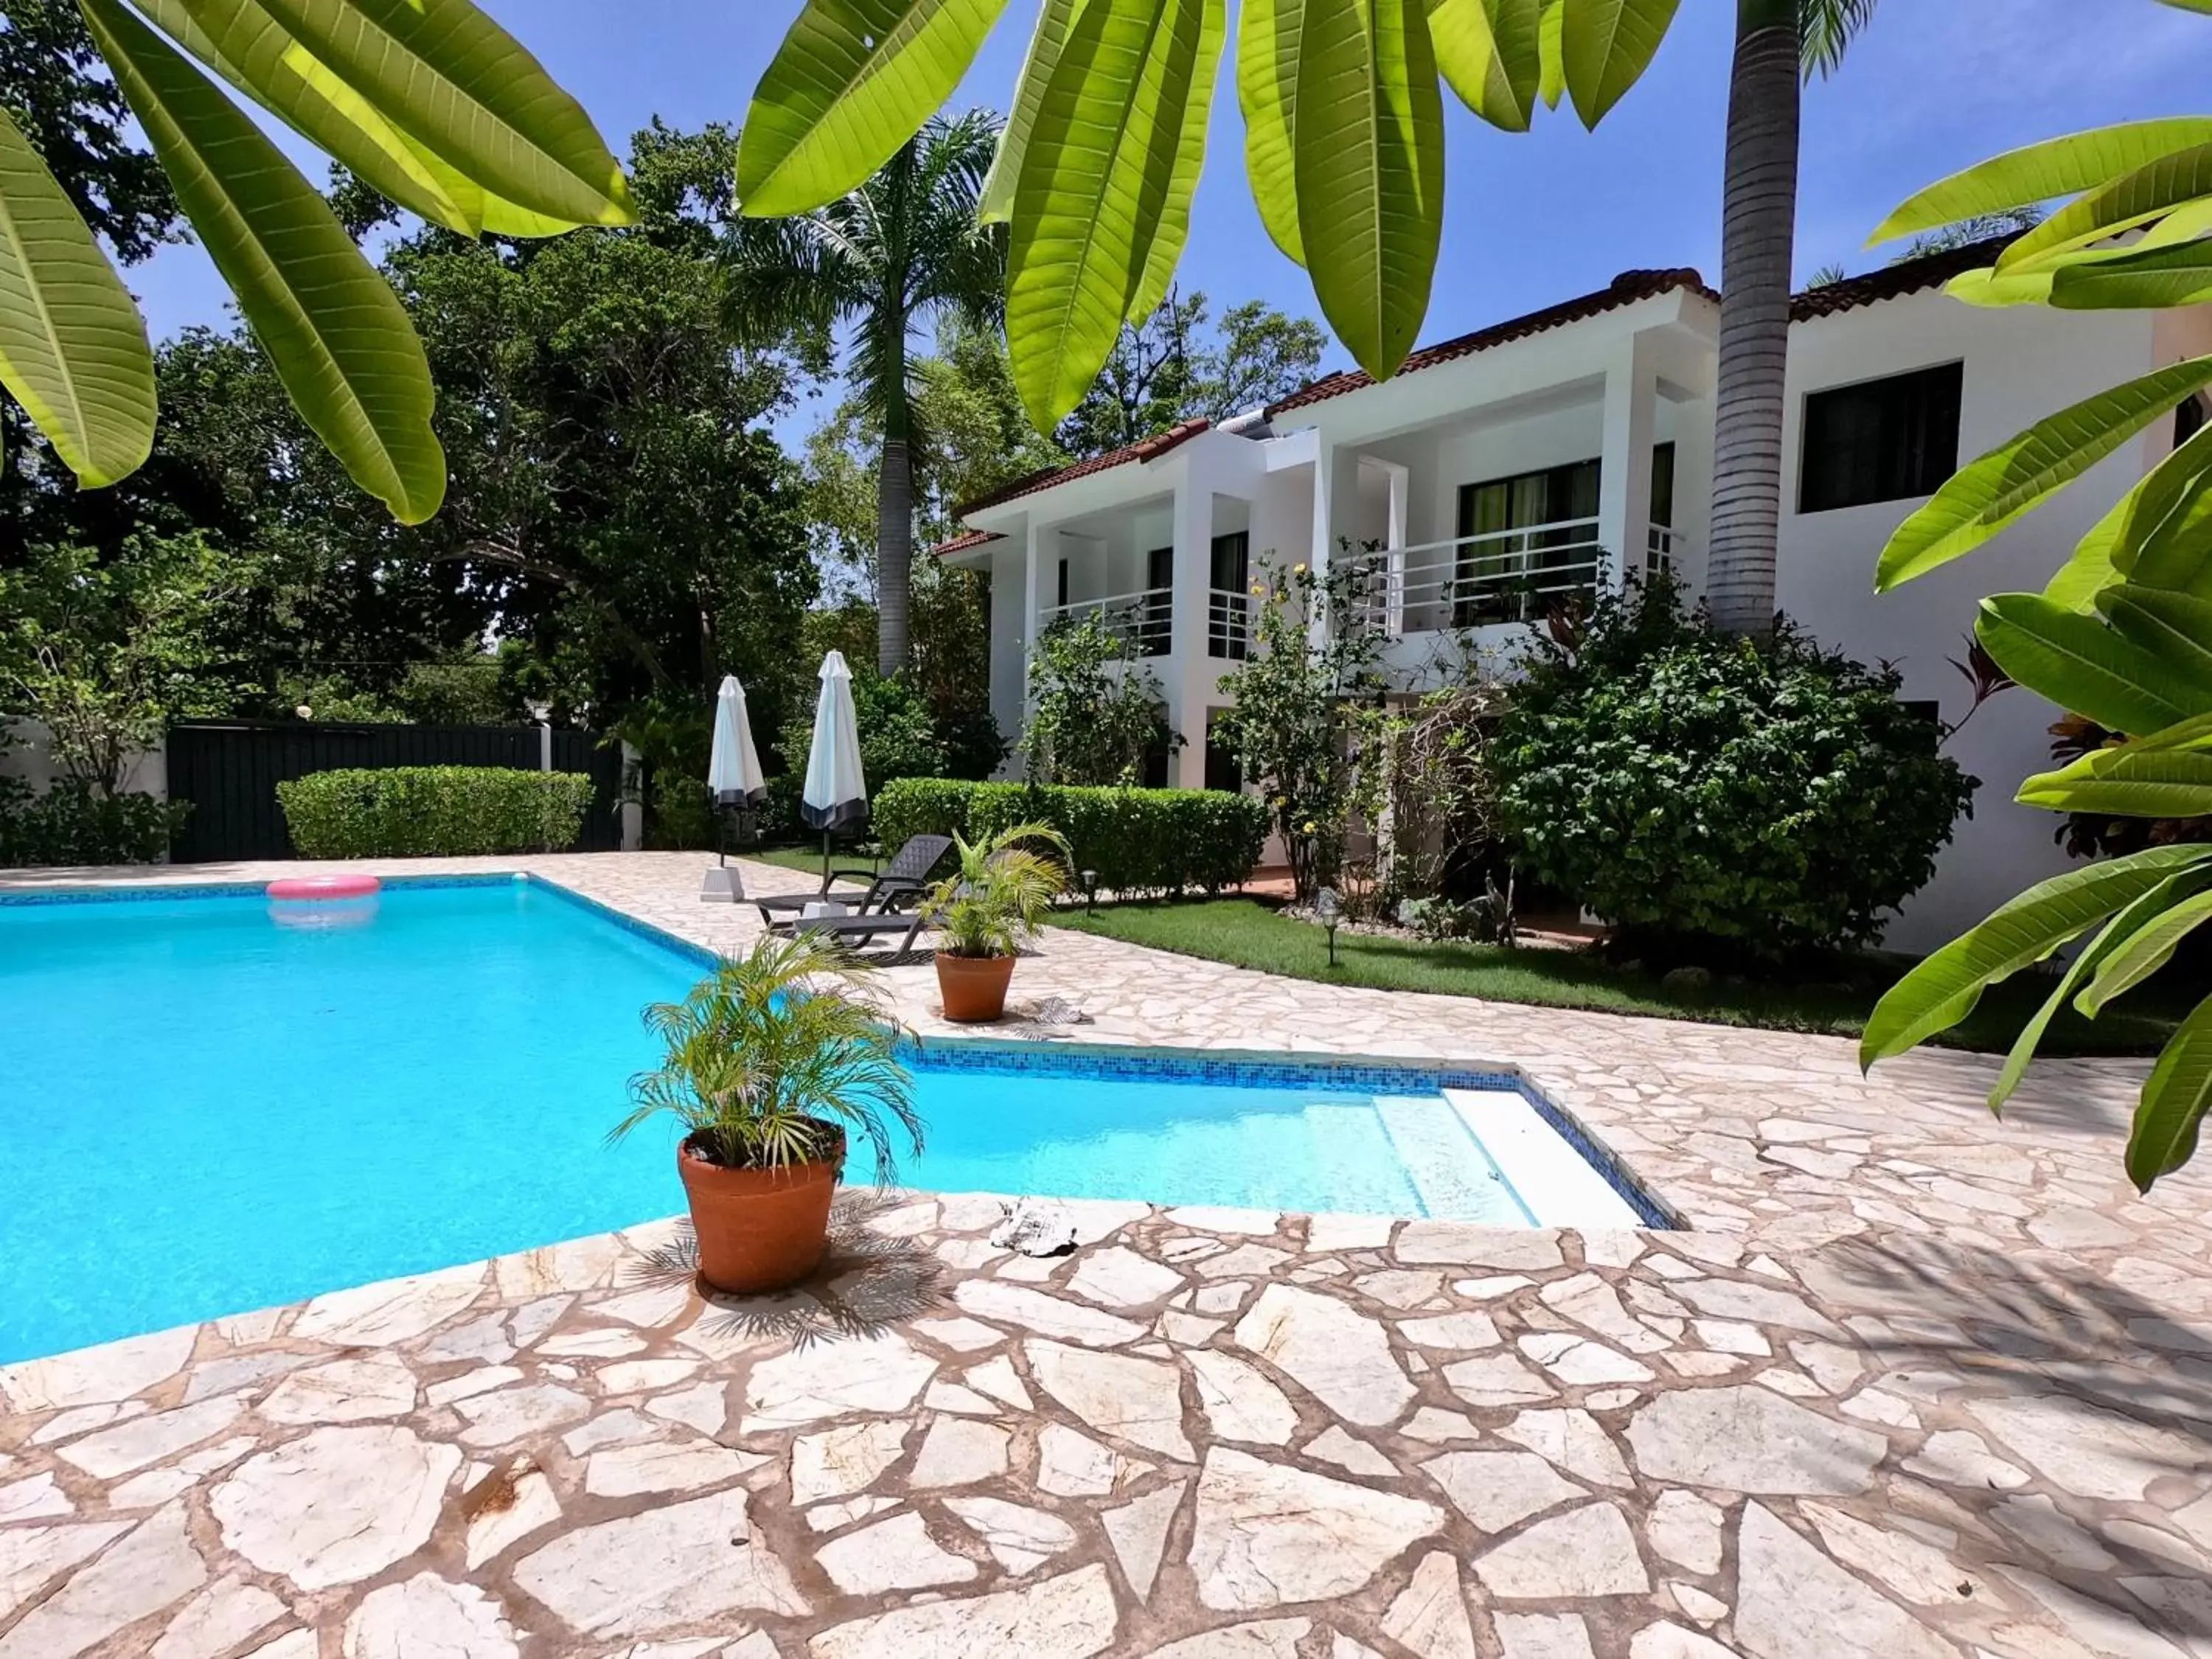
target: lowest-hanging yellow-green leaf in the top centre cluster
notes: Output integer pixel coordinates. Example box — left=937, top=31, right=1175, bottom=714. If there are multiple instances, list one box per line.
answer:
left=1006, top=0, right=1221, bottom=429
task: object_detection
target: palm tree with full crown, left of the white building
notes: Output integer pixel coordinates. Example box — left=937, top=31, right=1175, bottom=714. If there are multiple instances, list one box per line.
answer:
left=730, top=111, right=1006, bottom=675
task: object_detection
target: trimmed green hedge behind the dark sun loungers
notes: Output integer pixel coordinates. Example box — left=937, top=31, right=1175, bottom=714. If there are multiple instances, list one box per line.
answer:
left=874, top=779, right=1267, bottom=894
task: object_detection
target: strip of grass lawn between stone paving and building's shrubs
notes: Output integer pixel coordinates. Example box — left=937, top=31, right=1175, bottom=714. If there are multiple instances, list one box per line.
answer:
left=1053, top=898, right=2201, bottom=1055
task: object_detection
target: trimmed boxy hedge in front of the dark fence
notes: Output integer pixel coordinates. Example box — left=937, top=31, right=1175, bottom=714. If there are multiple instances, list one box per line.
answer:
left=276, top=765, right=591, bottom=858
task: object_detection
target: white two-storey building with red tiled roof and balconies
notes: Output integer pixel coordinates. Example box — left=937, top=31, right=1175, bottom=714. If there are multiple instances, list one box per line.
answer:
left=938, top=248, right=2212, bottom=949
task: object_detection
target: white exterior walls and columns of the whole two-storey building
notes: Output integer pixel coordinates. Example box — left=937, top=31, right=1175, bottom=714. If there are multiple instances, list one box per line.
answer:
left=947, top=290, right=2212, bottom=951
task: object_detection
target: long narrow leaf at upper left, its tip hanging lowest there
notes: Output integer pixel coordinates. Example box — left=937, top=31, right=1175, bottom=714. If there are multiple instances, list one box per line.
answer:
left=82, top=0, right=445, bottom=524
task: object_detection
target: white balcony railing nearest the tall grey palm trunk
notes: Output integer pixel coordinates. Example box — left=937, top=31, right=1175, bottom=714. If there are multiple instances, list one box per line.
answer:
left=1371, top=518, right=1606, bottom=635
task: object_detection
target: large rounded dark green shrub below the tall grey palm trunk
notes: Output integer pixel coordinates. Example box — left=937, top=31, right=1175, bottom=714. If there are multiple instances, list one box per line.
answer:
left=1491, top=582, right=1975, bottom=960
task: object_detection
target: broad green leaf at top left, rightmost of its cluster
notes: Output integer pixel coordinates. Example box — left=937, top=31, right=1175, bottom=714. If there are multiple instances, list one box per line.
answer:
left=261, top=0, right=633, bottom=226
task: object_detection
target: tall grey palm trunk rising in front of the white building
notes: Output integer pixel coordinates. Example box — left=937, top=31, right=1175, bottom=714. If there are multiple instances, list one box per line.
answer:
left=1705, top=0, right=1876, bottom=635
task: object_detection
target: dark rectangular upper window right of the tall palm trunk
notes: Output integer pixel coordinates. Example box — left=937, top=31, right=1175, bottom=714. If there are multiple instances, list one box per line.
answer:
left=1798, top=363, right=1966, bottom=513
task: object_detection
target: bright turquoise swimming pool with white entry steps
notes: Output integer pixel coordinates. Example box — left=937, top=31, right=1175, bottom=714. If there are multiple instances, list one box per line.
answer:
left=0, top=878, right=1659, bottom=1363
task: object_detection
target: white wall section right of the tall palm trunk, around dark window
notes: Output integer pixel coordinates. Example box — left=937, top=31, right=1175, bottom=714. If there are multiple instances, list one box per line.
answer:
left=1776, top=292, right=2179, bottom=951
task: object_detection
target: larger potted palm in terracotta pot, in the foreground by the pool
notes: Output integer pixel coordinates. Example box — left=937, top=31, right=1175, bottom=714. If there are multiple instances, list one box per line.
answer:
left=608, top=933, right=922, bottom=1294
